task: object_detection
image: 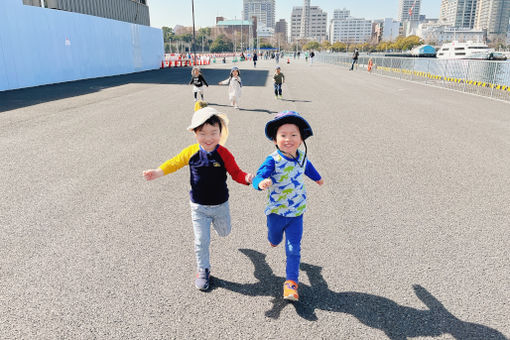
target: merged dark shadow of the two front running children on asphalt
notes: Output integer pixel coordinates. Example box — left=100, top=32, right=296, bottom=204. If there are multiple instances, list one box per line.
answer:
left=212, top=249, right=507, bottom=340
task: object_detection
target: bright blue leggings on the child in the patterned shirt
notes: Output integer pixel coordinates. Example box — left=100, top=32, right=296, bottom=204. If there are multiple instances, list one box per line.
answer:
left=267, top=214, right=303, bottom=283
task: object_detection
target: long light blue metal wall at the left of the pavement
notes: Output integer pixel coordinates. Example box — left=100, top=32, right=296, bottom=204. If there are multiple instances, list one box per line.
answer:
left=0, top=0, right=164, bottom=91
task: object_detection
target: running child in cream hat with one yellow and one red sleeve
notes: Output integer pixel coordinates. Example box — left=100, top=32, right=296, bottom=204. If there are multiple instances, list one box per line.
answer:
left=143, top=107, right=253, bottom=291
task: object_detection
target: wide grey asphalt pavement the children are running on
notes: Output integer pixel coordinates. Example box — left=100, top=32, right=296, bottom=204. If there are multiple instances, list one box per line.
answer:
left=0, top=60, right=510, bottom=339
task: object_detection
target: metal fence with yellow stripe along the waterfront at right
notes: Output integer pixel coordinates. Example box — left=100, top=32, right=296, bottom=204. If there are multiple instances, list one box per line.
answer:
left=316, top=53, right=510, bottom=101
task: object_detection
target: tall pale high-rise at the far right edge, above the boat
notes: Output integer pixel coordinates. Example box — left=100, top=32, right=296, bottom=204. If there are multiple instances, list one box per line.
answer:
left=475, top=0, right=510, bottom=40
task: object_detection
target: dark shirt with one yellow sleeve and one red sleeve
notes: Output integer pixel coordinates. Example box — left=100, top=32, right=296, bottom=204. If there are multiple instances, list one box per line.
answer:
left=159, top=144, right=249, bottom=205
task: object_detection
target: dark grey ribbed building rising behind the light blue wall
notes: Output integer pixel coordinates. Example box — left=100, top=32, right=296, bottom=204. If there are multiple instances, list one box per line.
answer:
left=22, top=0, right=150, bottom=26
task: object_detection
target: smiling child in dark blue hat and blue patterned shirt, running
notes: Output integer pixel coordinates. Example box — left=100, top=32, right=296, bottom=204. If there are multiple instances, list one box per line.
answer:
left=253, top=111, right=324, bottom=301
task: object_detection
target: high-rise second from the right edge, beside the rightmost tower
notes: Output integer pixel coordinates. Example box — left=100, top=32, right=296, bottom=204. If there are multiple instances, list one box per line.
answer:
left=439, top=0, right=477, bottom=28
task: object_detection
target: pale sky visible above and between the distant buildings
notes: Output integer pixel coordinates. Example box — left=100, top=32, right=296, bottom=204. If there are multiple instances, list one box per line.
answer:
left=147, top=0, right=441, bottom=29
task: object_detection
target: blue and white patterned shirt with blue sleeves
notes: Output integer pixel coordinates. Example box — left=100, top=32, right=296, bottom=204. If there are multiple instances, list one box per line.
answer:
left=253, top=150, right=321, bottom=217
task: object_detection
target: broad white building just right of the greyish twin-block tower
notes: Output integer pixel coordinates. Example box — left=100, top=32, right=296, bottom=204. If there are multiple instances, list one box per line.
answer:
left=329, top=17, right=372, bottom=44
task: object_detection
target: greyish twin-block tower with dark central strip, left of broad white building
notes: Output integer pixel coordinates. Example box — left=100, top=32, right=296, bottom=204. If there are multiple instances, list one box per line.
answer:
left=290, top=6, right=328, bottom=42
